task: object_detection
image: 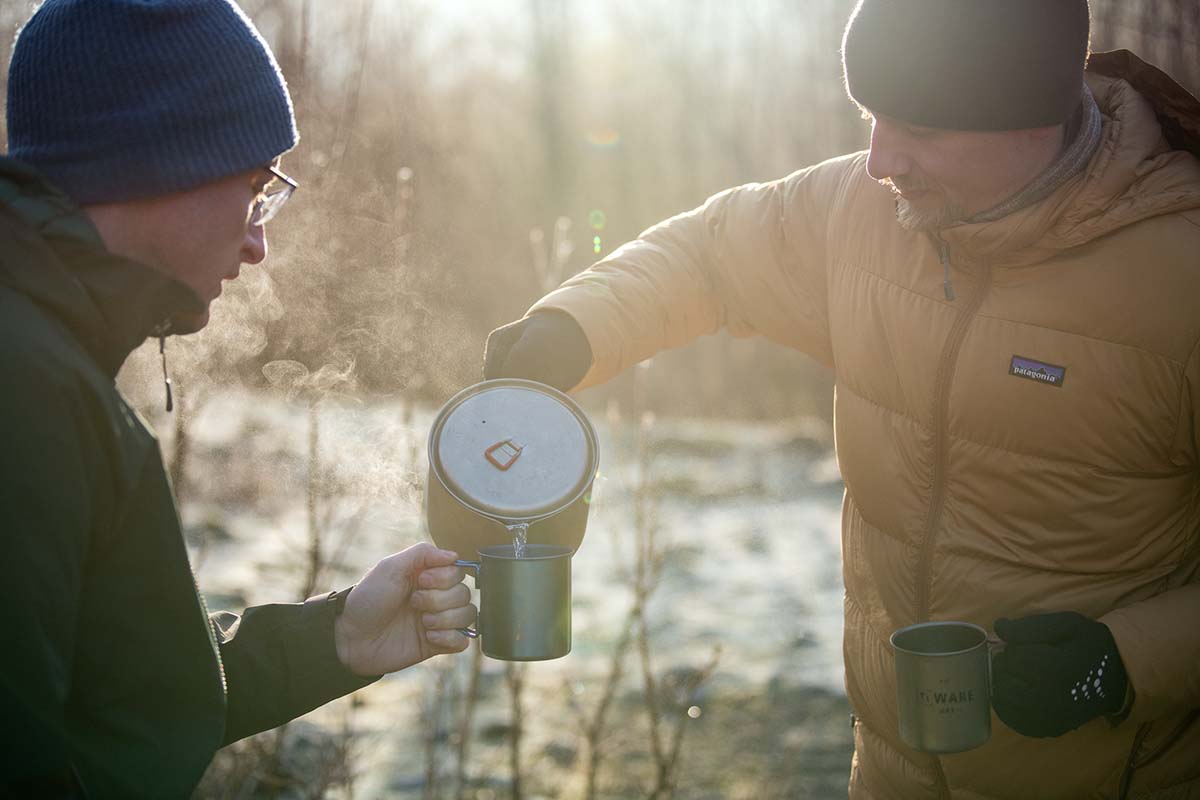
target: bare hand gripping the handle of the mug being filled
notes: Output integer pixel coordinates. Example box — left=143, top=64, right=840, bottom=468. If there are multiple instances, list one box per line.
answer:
left=334, top=542, right=476, bottom=675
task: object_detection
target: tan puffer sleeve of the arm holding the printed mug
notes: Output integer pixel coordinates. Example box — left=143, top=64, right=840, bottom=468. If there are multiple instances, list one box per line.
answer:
left=1100, top=341, right=1200, bottom=722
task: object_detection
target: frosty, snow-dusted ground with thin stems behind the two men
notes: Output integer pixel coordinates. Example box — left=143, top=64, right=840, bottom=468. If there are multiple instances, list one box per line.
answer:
left=155, top=392, right=848, bottom=798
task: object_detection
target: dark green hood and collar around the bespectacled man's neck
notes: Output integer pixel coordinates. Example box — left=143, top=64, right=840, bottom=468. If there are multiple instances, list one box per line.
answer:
left=0, top=157, right=203, bottom=378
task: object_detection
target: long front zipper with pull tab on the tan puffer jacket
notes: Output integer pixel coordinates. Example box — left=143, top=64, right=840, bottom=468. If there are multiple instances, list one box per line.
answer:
left=914, top=247, right=991, bottom=622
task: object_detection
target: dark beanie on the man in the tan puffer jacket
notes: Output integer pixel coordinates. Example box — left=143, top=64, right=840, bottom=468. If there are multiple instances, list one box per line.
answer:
left=842, top=0, right=1088, bottom=131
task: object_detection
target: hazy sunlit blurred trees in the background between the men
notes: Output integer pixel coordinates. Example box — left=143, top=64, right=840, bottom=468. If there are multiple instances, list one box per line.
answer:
left=0, top=0, right=1200, bottom=416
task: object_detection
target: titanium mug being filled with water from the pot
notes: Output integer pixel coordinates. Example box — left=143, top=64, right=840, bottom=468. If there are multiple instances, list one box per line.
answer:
left=455, top=543, right=574, bottom=661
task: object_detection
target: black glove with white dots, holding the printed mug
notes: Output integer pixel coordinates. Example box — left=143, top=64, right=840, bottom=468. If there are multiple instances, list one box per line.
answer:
left=991, top=612, right=1129, bottom=738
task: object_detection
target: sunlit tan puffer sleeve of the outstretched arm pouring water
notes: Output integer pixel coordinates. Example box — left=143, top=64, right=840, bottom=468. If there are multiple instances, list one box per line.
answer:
left=530, top=157, right=857, bottom=389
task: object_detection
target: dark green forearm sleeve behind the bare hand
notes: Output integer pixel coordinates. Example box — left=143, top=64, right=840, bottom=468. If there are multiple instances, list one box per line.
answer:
left=209, top=595, right=378, bottom=745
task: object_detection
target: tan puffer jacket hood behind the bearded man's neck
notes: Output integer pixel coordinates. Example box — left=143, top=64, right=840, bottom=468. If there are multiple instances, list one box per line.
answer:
left=941, top=50, right=1200, bottom=266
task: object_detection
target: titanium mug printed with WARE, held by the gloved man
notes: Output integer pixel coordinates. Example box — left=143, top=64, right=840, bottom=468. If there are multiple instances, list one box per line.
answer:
left=892, top=622, right=997, bottom=753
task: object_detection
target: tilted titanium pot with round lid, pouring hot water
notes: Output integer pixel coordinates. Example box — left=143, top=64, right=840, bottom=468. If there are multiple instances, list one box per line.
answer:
left=425, top=378, right=599, bottom=559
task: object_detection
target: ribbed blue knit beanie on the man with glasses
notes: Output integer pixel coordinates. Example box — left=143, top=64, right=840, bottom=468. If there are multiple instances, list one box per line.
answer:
left=7, top=0, right=299, bottom=204
